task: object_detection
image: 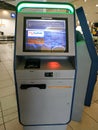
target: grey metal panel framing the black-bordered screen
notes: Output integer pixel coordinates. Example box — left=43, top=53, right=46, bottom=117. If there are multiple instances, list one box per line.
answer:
left=16, top=13, right=75, bottom=57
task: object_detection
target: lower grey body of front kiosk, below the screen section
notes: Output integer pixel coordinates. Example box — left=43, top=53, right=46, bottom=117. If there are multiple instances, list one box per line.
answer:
left=16, top=59, right=75, bottom=125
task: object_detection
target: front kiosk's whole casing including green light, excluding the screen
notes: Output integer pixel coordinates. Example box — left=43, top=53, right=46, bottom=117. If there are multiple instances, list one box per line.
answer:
left=14, top=1, right=76, bottom=130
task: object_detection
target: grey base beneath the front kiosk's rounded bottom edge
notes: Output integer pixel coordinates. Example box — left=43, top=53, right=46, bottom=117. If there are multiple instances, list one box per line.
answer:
left=23, top=125, right=67, bottom=130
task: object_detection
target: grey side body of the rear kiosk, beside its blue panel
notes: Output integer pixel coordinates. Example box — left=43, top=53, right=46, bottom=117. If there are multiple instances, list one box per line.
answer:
left=72, top=41, right=91, bottom=121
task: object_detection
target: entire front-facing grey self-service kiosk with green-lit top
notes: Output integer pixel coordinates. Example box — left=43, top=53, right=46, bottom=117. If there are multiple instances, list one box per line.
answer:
left=14, top=1, right=76, bottom=130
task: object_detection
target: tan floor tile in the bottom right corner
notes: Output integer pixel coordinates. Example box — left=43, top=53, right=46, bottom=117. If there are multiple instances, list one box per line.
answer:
left=69, top=113, right=98, bottom=130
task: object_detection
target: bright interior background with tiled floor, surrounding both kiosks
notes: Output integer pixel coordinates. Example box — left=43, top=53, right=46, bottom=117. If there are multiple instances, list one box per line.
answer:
left=0, top=0, right=98, bottom=130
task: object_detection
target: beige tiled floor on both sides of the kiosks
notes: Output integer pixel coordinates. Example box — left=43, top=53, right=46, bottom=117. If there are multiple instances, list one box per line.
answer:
left=0, top=42, right=98, bottom=130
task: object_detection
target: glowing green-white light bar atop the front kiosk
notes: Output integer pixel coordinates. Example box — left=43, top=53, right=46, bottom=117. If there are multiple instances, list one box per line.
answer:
left=17, top=1, right=75, bottom=14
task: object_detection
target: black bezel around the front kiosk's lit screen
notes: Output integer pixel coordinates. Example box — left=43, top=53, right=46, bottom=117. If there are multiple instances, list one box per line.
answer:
left=23, top=17, right=69, bottom=54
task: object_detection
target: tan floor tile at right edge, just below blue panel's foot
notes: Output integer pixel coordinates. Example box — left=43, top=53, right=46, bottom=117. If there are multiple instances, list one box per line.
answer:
left=84, top=103, right=98, bottom=123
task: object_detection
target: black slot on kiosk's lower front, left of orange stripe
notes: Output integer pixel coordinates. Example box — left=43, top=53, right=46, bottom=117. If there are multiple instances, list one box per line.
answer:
left=20, top=84, right=46, bottom=89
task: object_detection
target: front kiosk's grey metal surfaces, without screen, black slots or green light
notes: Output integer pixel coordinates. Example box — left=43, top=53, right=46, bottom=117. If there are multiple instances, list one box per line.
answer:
left=15, top=2, right=75, bottom=127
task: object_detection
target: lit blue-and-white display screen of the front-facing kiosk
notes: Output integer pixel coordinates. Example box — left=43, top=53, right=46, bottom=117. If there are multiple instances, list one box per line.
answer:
left=23, top=17, right=68, bottom=53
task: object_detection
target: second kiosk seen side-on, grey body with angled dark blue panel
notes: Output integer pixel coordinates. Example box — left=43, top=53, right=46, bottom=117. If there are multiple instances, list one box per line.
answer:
left=72, top=7, right=98, bottom=121
